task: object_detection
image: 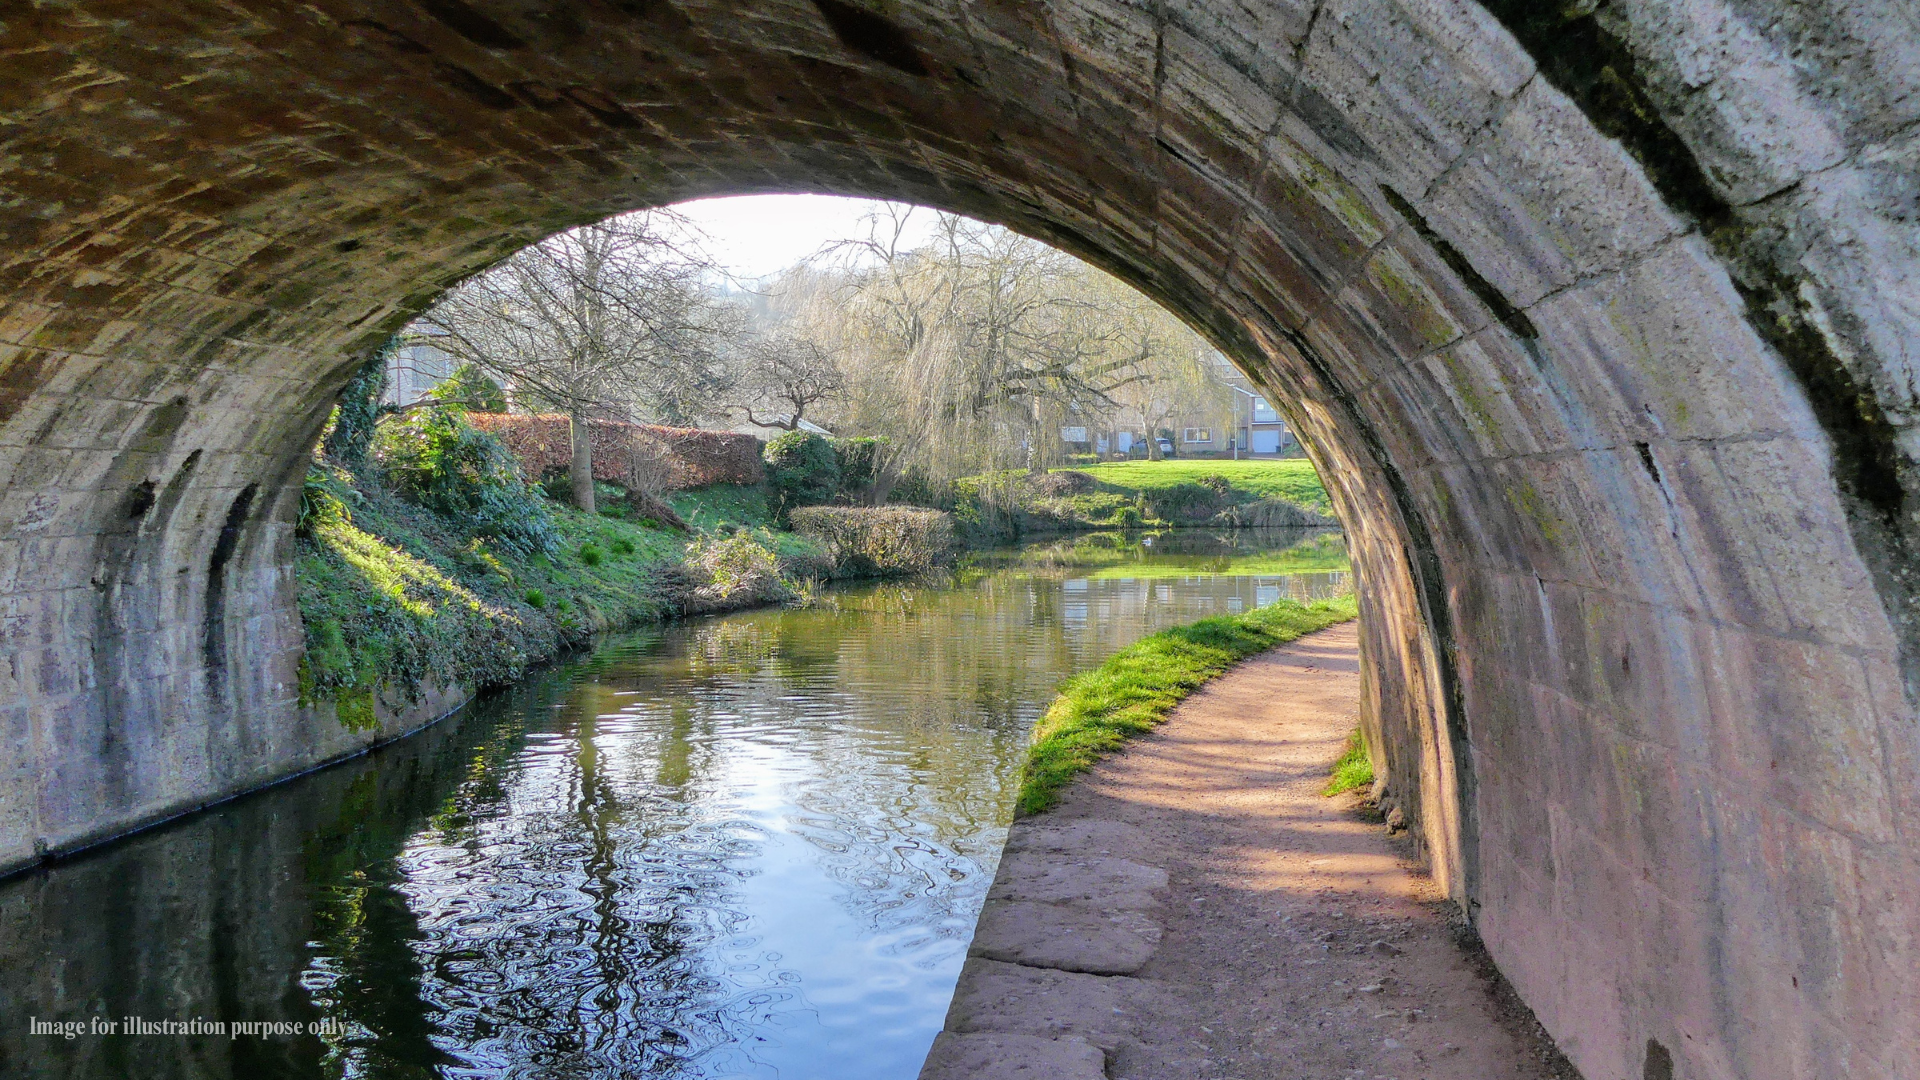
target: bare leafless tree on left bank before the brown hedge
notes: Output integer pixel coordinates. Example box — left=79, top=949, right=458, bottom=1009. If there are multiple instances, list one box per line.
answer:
left=424, top=211, right=737, bottom=511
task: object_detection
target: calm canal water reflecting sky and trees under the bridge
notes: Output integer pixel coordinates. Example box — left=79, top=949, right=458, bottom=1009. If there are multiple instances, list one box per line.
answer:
left=0, top=530, right=1352, bottom=1080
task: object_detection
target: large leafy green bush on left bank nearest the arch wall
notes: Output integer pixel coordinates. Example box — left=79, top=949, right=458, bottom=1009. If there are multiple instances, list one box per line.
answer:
left=376, top=409, right=559, bottom=555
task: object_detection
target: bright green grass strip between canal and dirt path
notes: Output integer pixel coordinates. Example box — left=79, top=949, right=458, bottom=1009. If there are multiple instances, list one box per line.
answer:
left=1016, top=596, right=1357, bottom=817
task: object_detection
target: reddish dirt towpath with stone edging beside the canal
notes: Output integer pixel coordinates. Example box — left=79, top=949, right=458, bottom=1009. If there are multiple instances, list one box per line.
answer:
left=922, top=623, right=1571, bottom=1080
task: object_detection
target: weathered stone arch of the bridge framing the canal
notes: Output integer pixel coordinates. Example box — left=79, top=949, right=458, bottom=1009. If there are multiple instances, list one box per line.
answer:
left=0, top=0, right=1920, bottom=1080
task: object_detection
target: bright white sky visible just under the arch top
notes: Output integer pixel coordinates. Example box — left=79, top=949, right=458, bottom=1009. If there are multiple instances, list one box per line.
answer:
left=674, top=194, right=933, bottom=281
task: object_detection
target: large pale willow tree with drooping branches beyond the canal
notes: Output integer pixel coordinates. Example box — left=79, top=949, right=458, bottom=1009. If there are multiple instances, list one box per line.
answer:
left=774, top=206, right=1204, bottom=482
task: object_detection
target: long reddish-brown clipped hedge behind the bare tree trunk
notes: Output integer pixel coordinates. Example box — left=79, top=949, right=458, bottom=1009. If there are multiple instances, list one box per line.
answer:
left=467, top=413, right=766, bottom=490
